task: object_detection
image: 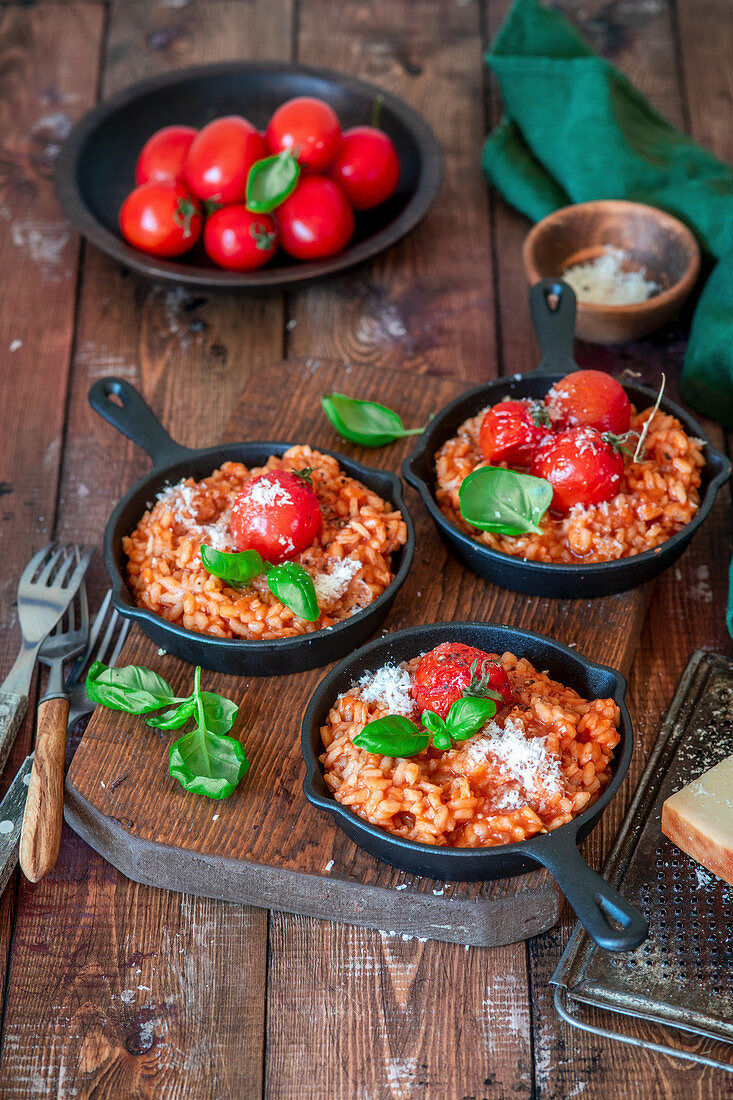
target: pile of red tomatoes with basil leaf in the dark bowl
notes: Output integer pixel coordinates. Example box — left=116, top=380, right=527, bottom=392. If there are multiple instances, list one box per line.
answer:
left=120, top=97, right=400, bottom=272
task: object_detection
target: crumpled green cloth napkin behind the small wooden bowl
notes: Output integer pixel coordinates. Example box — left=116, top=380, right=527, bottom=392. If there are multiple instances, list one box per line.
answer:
left=483, top=0, right=733, bottom=429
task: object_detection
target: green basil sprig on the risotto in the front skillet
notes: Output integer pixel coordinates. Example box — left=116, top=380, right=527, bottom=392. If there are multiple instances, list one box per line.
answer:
left=353, top=695, right=496, bottom=757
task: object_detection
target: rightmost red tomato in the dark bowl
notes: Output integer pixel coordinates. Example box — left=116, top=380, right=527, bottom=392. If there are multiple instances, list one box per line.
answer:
left=329, top=127, right=400, bottom=210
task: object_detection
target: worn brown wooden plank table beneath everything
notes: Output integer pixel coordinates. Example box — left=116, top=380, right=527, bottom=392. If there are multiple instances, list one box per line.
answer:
left=0, top=0, right=733, bottom=1100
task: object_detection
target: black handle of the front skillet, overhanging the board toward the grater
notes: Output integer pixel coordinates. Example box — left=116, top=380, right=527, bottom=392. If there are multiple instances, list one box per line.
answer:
left=532, top=825, right=649, bottom=952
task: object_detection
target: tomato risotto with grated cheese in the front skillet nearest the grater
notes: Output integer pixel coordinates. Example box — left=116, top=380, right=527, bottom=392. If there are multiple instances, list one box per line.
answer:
left=320, top=653, right=620, bottom=848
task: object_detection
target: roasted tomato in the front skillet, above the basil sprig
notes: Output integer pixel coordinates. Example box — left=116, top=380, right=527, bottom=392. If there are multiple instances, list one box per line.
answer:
left=413, top=641, right=513, bottom=718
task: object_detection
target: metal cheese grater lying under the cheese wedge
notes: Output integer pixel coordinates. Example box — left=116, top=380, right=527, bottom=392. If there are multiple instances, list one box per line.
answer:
left=550, top=650, right=733, bottom=1073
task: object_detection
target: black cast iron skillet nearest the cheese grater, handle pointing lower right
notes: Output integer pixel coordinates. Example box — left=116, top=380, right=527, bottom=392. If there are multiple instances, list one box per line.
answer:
left=302, top=623, right=648, bottom=952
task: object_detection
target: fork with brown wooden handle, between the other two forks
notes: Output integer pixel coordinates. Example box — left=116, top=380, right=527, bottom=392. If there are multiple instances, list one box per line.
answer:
left=20, top=584, right=89, bottom=882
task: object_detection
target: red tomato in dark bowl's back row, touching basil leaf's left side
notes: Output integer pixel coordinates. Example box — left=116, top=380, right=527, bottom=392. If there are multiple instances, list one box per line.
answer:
left=186, top=114, right=267, bottom=204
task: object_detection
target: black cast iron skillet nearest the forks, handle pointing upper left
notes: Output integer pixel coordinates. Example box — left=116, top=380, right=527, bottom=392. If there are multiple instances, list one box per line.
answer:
left=89, top=378, right=415, bottom=677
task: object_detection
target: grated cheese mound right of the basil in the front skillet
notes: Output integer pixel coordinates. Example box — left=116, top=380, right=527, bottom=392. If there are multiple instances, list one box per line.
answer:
left=466, top=718, right=562, bottom=798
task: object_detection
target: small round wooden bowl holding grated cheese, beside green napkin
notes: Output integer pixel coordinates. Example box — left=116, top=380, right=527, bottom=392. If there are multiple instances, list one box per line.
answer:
left=523, top=199, right=700, bottom=343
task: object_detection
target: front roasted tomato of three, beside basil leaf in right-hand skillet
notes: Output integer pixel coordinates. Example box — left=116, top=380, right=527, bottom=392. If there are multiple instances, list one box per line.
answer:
left=529, top=428, right=624, bottom=515
